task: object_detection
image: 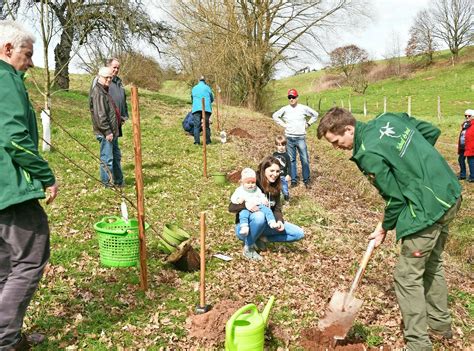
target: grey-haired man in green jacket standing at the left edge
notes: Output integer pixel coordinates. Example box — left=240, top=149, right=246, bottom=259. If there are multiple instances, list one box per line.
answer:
left=0, top=21, right=58, bottom=350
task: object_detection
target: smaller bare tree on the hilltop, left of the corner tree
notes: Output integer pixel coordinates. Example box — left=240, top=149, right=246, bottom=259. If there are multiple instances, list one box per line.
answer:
left=405, top=10, right=438, bottom=66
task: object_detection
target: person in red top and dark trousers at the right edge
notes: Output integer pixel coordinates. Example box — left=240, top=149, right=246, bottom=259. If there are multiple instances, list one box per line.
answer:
left=458, top=110, right=474, bottom=183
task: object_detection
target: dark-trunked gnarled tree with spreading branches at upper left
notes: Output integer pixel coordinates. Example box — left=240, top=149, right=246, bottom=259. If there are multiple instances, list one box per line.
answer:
left=25, top=0, right=171, bottom=89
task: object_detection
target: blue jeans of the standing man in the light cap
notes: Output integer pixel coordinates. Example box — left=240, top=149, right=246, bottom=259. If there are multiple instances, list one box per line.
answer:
left=96, top=135, right=123, bottom=186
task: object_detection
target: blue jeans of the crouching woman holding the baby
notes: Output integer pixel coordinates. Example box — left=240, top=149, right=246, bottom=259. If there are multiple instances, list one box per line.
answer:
left=235, top=211, right=304, bottom=247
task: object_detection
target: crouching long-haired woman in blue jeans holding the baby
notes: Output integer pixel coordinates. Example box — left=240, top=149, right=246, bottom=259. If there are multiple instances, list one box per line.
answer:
left=229, top=156, right=304, bottom=261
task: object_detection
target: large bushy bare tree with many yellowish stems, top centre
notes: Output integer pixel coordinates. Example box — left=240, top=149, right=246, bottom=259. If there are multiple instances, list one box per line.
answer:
left=170, top=0, right=365, bottom=109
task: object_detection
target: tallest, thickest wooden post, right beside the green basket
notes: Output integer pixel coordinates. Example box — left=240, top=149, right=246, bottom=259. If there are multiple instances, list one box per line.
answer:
left=132, top=86, right=148, bottom=291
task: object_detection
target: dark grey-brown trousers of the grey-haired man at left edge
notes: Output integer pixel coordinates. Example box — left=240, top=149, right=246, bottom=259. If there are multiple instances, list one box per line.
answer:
left=0, top=200, right=49, bottom=351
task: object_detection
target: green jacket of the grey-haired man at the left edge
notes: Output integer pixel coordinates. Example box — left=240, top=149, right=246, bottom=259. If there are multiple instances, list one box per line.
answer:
left=0, top=60, right=55, bottom=210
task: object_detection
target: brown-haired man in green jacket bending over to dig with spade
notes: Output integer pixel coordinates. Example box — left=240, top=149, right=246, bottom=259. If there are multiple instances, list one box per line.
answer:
left=318, top=107, right=461, bottom=351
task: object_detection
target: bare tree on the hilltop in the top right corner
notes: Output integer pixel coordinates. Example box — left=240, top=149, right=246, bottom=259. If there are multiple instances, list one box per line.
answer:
left=430, top=0, right=474, bottom=64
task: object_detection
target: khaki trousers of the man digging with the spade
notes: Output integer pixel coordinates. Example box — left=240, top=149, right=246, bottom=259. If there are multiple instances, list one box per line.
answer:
left=394, top=198, right=461, bottom=351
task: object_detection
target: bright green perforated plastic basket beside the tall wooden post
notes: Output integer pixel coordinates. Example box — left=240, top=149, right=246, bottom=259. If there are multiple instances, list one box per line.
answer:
left=94, top=216, right=150, bottom=267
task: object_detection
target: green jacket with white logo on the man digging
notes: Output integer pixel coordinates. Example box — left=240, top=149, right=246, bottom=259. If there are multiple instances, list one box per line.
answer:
left=351, top=113, right=461, bottom=240
